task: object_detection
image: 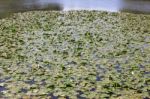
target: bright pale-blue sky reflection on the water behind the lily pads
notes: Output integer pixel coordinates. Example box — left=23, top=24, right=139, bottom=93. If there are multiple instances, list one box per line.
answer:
left=39, top=0, right=120, bottom=11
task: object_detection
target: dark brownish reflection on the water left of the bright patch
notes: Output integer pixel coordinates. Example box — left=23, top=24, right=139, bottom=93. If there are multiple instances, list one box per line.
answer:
left=0, top=0, right=62, bottom=18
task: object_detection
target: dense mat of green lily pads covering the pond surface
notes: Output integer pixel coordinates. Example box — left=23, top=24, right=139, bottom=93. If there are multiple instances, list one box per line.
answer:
left=0, top=11, right=150, bottom=99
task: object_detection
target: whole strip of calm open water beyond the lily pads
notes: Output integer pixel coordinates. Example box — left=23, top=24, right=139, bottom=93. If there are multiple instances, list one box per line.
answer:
left=0, top=0, right=150, bottom=16
